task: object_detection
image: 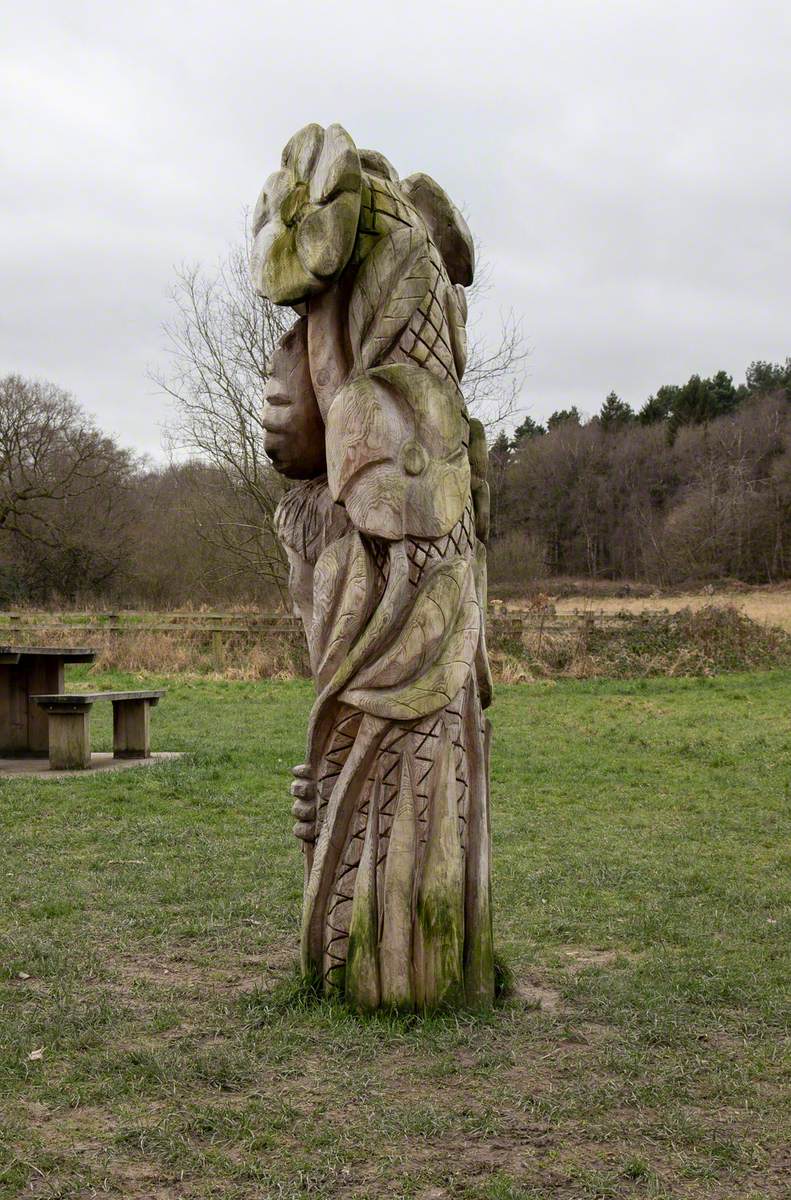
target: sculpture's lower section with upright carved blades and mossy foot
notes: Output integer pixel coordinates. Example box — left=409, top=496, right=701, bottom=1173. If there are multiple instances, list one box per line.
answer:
left=302, top=686, right=495, bottom=1012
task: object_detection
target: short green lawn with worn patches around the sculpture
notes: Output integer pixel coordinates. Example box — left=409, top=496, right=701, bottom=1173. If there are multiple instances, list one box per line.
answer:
left=0, top=672, right=791, bottom=1200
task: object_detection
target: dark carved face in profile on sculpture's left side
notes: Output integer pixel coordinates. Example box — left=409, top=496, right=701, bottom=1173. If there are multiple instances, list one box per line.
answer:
left=262, top=317, right=326, bottom=479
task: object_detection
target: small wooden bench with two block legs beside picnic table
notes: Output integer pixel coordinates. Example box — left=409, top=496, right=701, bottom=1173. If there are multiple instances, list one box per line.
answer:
left=30, top=691, right=164, bottom=770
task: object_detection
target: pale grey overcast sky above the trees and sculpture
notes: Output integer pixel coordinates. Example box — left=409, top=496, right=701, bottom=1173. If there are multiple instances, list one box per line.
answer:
left=0, top=0, right=791, bottom=458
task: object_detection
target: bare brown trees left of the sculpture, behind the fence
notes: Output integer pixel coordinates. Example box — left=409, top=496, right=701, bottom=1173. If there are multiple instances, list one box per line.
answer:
left=0, top=376, right=294, bottom=607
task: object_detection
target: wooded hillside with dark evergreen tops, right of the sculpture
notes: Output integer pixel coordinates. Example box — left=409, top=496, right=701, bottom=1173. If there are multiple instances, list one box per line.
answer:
left=491, top=359, right=791, bottom=586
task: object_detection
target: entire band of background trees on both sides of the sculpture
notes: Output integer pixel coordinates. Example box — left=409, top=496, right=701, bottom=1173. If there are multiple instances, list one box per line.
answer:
left=0, top=282, right=791, bottom=607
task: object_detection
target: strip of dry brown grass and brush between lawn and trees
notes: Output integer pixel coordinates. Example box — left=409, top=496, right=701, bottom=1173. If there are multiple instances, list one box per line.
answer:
left=0, top=589, right=791, bottom=683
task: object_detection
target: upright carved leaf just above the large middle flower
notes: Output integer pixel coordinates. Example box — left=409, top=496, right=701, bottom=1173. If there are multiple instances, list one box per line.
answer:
left=349, top=226, right=436, bottom=370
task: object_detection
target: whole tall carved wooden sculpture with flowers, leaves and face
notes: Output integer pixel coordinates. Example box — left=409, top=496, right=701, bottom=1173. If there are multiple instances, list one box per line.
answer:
left=252, top=125, right=493, bottom=1009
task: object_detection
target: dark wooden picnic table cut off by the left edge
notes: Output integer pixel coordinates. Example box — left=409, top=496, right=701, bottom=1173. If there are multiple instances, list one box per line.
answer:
left=0, top=646, right=96, bottom=758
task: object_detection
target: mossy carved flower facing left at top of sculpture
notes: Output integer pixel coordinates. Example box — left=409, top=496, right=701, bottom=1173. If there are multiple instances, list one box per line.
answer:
left=251, top=125, right=361, bottom=305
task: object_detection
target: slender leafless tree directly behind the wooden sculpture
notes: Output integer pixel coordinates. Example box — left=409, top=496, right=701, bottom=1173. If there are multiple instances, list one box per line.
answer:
left=154, top=232, right=527, bottom=599
